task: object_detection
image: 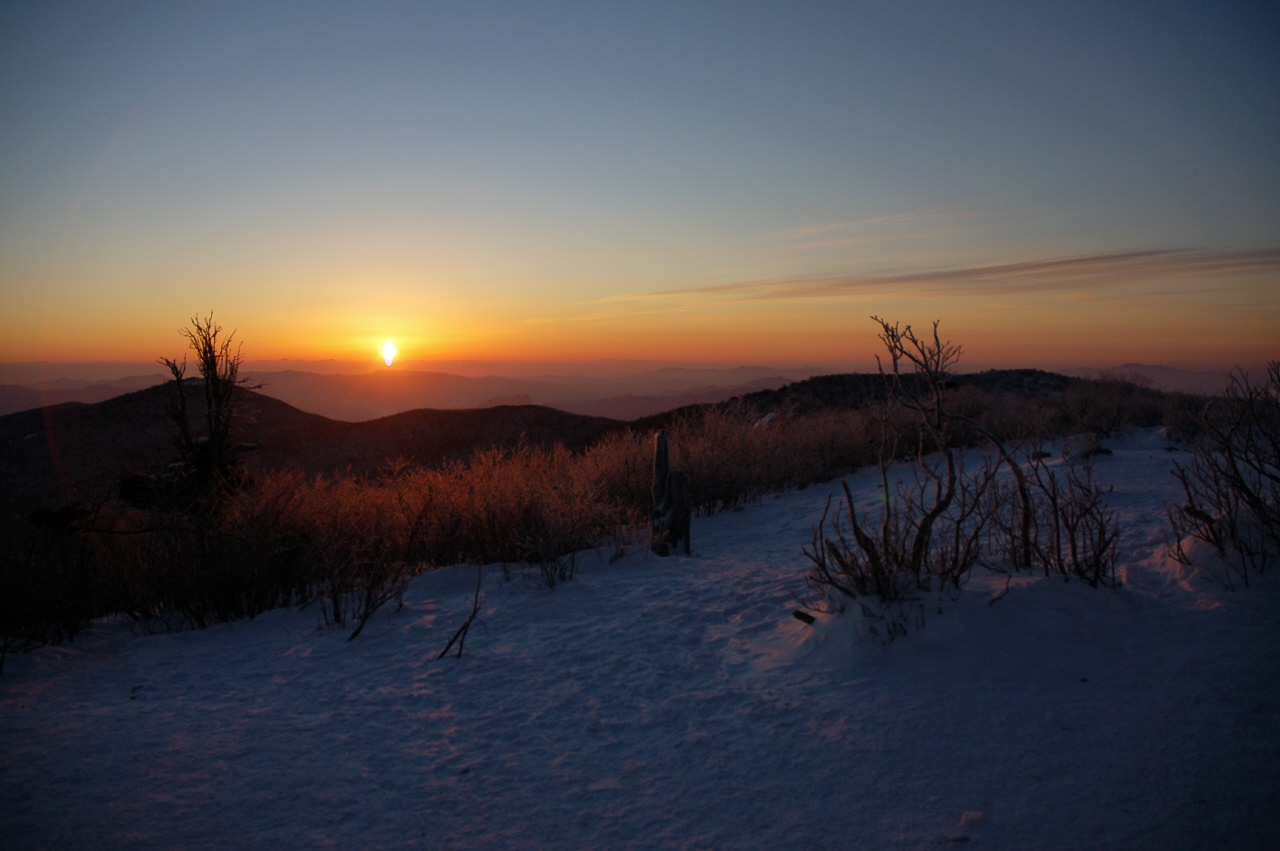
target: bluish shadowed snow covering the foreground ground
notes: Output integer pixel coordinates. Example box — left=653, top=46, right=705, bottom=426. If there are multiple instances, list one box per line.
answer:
left=0, top=431, right=1280, bottom=850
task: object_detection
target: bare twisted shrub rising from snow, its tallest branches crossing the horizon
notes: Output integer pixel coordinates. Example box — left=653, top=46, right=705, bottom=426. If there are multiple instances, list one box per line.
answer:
left=804, top=319, right=1119, bottom=640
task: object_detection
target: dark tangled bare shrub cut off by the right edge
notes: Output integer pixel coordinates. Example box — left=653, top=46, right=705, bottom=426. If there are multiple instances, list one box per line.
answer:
left=1166, top=361, right=1280, bottom=589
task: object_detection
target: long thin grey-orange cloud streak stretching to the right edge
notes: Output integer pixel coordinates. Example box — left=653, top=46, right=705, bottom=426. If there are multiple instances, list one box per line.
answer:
left=602, top=248, right=1280, bottom=301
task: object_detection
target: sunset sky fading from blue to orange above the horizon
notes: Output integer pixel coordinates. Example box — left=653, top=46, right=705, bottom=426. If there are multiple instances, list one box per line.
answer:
left=0, top=3, right=1280, bottom=365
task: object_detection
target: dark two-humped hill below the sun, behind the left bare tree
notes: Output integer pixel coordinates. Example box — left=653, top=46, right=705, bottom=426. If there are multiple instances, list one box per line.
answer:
left=0, top=386, right=621, bottom=513
